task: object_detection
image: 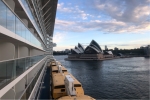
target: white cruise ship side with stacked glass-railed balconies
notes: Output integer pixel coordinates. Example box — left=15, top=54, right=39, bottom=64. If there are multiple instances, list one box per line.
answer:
left=0, top=0, right=58, bottom=99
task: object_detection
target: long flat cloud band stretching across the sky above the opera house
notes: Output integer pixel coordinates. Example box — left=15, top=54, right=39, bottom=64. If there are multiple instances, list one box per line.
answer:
left=55, top=19, right=150, bottom=33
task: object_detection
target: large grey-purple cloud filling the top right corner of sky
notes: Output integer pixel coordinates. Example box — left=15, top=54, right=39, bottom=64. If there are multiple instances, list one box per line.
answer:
left=87, top=0, right=150, bottom=24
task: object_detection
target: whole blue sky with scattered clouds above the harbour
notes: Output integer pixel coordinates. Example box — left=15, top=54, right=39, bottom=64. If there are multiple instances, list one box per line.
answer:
left=53, top=0, right=150, bottom=51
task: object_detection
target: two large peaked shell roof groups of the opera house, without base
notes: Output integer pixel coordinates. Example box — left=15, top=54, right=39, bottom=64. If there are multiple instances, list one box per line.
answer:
left=71, top=40, right=103, bottom=54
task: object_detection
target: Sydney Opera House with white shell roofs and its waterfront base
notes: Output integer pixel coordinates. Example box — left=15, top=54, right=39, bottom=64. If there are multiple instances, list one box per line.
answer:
left=66, top=40, right=113, bottom=60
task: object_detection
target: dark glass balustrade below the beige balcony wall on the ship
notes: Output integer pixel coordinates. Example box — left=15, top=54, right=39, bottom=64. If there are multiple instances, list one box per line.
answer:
left=0, top=55, right=46, bottom=89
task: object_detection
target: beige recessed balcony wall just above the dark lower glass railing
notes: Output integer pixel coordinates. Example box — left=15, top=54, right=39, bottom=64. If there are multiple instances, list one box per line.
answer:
left=0, top=41, right=45, bottom=61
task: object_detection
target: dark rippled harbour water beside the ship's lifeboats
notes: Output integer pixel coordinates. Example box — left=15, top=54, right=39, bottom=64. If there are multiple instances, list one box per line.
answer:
left=55, top=56, right=150, bottom=99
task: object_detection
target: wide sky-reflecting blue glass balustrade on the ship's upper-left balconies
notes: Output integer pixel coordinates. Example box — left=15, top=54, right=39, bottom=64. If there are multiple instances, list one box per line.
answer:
left=0, top=0, right=44, bottom=49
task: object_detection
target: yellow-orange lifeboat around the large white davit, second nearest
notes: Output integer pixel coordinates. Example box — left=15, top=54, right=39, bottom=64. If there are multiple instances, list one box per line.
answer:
left=52, top=72, right=84, bottom=99
